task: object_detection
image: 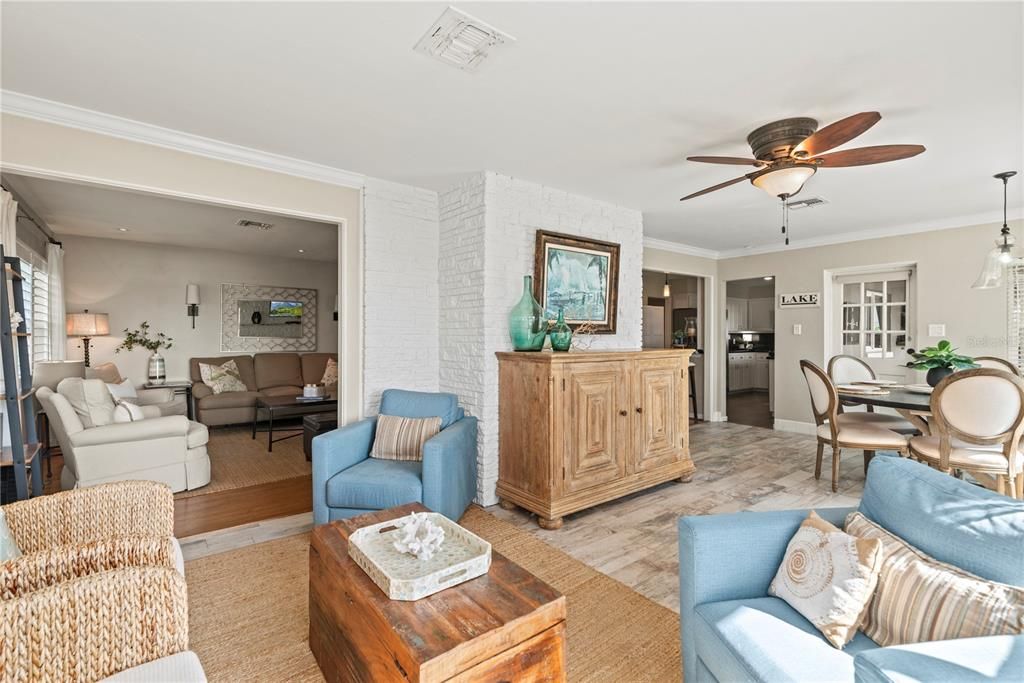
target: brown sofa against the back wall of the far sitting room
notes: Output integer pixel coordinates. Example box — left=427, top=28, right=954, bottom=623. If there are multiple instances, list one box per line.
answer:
left=188, top=353, right=338, bottom=426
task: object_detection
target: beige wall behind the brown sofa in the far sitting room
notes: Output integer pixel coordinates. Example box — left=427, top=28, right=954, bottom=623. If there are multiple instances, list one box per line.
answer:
left=58, top=236, right=338, bottom=385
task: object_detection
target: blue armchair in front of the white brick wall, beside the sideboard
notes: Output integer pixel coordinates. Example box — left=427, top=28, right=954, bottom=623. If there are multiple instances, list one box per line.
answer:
left=313, top=389, right=476, bottom=524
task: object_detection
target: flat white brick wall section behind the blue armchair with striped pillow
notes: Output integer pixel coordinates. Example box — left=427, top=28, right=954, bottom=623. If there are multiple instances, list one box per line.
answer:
left=362, top=178, right=439, bottom=415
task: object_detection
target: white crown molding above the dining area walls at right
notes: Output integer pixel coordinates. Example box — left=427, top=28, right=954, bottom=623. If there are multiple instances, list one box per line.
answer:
left=643, top=208, right=1024, bottom=261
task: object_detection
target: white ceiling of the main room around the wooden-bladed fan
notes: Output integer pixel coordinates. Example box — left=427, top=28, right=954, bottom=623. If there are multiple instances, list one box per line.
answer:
left=2, top=0, right=1024, bottom=250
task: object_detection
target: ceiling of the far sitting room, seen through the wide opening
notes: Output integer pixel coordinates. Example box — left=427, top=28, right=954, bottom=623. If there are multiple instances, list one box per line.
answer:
left=3, top=173, right=338, bottom=261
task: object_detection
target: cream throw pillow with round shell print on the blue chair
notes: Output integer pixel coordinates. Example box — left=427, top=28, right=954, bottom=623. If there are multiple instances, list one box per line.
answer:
left=768, top=511, right=883, bottom=649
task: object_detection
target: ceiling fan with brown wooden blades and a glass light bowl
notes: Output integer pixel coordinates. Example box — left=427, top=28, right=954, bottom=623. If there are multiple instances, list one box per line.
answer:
left=680, top=112, right=925, bottom=203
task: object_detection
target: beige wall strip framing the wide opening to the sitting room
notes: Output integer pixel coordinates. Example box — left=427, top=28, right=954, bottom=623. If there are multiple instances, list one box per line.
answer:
left=0, top=114, right=362, bottom=421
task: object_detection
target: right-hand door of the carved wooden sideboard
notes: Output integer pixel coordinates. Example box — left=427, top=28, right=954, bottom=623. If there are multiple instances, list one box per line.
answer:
left=631, top=358, right=686, bottom=472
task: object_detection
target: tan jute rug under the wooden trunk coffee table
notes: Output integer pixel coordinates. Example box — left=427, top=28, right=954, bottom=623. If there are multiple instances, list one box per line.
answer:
left=185, top=506, right=682, bottom=683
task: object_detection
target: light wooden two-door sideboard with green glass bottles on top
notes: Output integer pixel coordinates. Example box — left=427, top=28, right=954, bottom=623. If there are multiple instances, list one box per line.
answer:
left=497, top=349, right=693, bottom=528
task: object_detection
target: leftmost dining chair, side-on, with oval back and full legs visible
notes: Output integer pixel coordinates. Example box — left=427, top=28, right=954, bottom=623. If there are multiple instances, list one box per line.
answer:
left=800, top=360, right=907, bottom=493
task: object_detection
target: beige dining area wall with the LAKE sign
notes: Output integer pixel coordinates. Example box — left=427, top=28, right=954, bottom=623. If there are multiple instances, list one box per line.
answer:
left=716, top=221, right=1022, bottom=426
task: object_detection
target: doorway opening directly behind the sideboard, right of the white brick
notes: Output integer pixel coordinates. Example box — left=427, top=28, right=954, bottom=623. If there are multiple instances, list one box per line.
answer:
left=643, top=270, right=711, bottom=423
